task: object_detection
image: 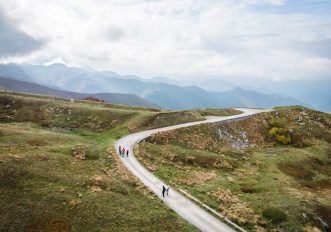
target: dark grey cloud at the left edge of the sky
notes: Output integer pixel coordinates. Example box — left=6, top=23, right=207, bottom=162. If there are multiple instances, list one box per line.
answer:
left=0, top=8, right=44, bottom=58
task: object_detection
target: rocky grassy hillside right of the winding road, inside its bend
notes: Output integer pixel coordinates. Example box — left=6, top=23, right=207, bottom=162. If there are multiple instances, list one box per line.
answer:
left=136, top=108, right=331, bottom=231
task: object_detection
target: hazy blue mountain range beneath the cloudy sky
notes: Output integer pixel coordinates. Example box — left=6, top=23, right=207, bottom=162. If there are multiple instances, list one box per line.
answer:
left=0, top=64, right=308, bottom=110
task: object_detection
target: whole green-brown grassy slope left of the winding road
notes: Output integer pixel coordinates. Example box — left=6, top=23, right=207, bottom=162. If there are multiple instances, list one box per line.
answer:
left=0, top=93, right=202, bottom=231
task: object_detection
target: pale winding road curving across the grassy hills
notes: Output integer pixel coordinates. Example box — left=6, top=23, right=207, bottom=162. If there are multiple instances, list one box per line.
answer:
left=115, top=108, right=267, bottom=232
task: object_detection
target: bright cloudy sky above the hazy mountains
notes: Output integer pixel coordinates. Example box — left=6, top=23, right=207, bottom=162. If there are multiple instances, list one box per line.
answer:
left=0, top=0, right=331, bottom=80
